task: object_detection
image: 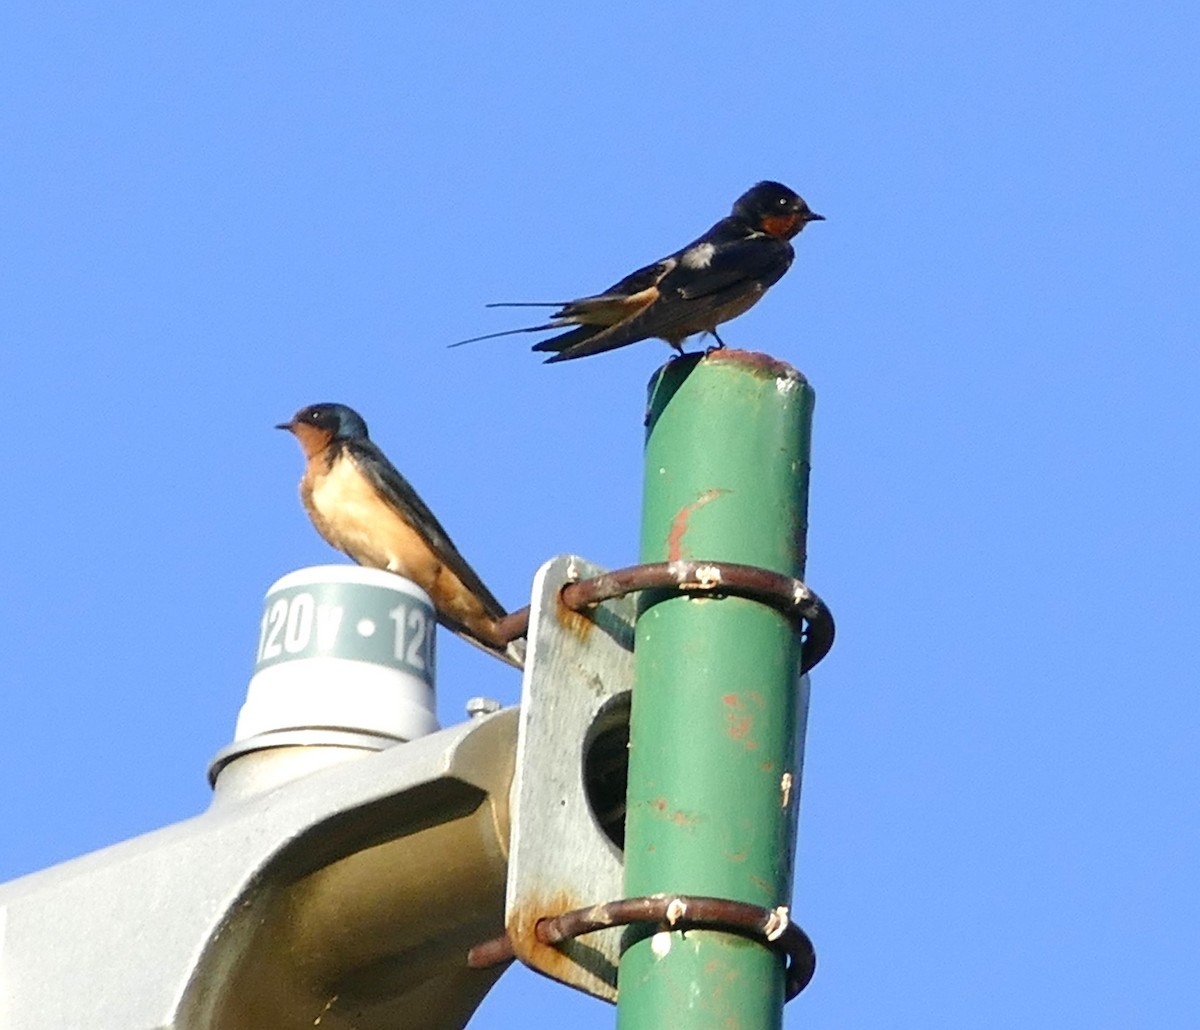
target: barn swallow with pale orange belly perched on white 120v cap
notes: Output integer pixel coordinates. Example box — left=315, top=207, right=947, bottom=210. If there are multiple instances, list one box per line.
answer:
left=276, top=405, right=524, bottom=667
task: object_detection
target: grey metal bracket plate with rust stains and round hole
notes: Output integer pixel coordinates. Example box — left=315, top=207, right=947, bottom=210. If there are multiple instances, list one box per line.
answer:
left=505, top=556, right=637, bottom=1001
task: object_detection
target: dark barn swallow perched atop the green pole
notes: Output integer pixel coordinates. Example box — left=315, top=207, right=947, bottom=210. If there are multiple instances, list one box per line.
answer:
left=450, top=181, right=824, bottom=364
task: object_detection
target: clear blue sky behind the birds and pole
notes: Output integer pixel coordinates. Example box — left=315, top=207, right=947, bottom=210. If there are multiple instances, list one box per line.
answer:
left=0, top=2, right=1200, bottom=1030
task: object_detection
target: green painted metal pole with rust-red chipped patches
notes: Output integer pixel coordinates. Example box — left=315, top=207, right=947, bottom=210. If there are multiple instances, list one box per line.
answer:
left=617, top=351, right=814, bottom=1030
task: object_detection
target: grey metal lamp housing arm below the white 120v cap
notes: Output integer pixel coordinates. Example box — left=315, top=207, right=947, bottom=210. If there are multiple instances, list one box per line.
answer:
left=0, top=709, right=517, bottom=1030
